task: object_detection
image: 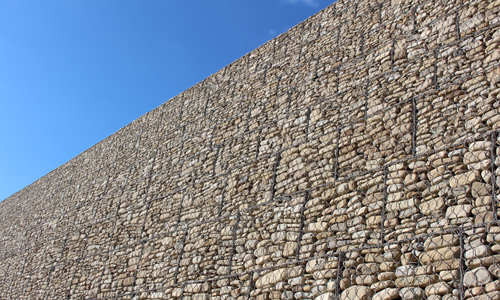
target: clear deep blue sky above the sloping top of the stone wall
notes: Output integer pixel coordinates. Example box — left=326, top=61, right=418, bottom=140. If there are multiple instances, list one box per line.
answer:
left=0, top=0, right=334, bottom=201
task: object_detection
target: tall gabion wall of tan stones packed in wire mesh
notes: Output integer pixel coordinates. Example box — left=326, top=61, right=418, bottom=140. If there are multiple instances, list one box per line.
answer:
left=0, top=0, right=500, bottom=300
